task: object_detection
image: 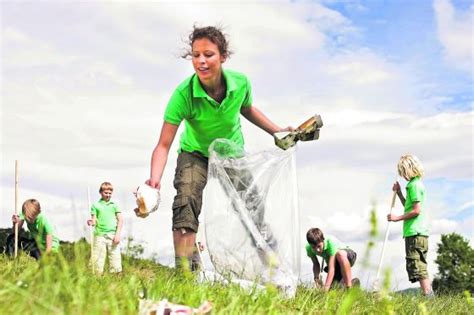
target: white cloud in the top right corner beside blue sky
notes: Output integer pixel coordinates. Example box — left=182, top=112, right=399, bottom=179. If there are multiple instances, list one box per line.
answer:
left=433, top=0, right=474, bottom=72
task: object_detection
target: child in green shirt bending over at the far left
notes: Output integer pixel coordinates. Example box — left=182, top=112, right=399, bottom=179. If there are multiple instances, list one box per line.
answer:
left=12, top=199, right=59, bottom=259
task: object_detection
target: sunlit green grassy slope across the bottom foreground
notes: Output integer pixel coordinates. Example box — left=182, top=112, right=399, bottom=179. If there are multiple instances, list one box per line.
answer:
left=0, top=236, right=474, bottom=314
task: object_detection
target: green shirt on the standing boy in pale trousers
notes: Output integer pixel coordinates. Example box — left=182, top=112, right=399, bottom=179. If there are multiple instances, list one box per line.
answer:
left=91, top=199, right=120, bottom=235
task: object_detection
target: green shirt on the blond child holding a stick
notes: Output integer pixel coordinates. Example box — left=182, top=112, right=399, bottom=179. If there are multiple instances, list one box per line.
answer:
left=403, top=177, right=429, bottom=237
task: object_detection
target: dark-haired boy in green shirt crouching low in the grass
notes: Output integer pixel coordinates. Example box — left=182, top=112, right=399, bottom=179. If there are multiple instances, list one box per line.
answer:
left=306, top=228, right=359, bottom=291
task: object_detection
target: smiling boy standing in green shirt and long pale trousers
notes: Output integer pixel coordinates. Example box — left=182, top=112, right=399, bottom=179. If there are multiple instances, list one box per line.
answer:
left=87, top=182, right=123, bottom=274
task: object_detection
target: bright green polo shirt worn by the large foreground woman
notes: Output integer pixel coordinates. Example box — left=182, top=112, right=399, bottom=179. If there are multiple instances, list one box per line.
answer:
left=164, top=70, right=252, bottom=157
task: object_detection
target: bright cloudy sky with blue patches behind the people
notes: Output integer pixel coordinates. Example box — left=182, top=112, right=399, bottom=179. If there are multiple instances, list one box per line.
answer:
left=0, top=0, right=474, bottom=289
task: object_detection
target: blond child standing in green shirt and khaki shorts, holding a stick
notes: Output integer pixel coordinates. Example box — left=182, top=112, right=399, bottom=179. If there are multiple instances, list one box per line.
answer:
left=387, top=155, right=433, bottom=296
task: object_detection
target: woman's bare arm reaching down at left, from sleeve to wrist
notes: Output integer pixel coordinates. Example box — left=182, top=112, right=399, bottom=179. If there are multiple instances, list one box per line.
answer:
left=146, top=122, right=179, bottom=189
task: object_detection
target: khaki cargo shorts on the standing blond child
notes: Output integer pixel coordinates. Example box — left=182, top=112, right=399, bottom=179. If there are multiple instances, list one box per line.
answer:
left=405, top=235, right=428, bottom=282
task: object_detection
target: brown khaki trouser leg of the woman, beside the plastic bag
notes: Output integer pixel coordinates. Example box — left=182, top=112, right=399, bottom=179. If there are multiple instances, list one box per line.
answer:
left=172, top=151, right=208, bottom=233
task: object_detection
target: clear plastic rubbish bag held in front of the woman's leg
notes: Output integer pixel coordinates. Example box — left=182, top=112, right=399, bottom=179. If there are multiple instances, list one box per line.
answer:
left=203, top=139, right=301, bottom=296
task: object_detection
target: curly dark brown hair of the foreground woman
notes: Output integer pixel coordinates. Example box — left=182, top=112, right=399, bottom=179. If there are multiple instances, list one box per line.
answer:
left=181, top=25, right=232, bottom=59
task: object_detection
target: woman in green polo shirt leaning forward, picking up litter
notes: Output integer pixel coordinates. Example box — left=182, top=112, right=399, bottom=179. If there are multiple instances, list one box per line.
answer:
left=146, top=26, right=292, bottom=269
